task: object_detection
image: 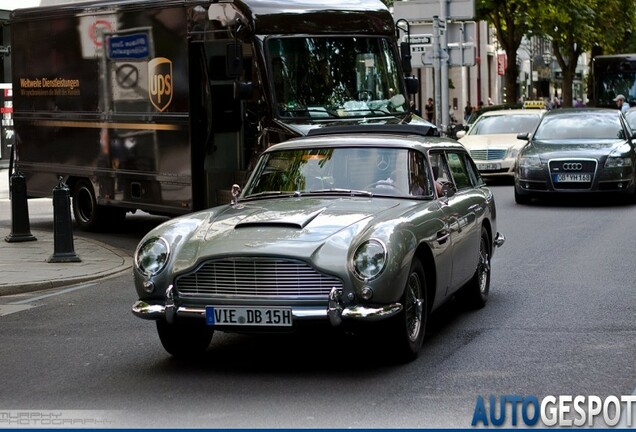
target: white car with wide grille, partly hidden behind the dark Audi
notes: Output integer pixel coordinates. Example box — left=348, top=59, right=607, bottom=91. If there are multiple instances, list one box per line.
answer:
left=457, top=109, right=546, bottom=177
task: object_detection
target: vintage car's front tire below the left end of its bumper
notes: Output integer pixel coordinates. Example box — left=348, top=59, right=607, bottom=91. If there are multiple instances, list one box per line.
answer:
left=157, top=319, right=214, bottom=358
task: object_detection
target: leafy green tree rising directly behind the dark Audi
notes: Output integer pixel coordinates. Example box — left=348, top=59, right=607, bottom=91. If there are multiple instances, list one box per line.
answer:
left=529, top=0, right=636, bottom=107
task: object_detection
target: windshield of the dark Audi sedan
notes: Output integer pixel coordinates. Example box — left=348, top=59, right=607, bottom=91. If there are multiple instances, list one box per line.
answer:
left=534, top=114, right=626, bottom=140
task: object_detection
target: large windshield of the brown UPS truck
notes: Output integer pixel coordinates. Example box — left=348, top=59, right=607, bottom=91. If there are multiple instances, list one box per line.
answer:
left=267, top=36, right=408, bottom=118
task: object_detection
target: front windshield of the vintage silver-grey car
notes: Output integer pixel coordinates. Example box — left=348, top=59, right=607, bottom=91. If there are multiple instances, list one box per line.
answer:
left=242, top=147, right=433, bottom=198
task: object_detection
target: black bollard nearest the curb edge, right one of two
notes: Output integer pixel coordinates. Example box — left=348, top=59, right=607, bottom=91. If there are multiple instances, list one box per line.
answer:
left=47, top=177, right=82, bottom=263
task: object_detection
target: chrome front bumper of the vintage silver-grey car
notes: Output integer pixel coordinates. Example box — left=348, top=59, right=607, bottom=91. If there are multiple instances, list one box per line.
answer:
left=132, top=287, right=402, bottom=326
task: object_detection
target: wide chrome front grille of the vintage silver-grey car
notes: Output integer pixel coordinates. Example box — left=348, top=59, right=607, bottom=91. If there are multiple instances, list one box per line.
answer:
left=175, top=257, right=343, bottom=300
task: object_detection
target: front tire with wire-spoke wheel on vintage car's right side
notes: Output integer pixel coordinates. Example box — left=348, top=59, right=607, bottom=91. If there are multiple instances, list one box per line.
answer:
left=387, top=258, right=428, bottom=361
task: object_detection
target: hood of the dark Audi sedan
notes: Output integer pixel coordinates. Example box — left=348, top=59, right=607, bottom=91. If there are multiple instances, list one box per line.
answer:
left=523, top=140, right=627, bottom=159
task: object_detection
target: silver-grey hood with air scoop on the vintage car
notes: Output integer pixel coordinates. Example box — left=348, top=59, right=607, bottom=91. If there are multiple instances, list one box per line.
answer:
left=170, top=197, right=410, bottom=271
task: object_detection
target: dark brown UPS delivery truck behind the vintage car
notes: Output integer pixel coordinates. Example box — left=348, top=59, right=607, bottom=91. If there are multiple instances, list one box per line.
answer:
left=10, top=0, right=436, bottom=230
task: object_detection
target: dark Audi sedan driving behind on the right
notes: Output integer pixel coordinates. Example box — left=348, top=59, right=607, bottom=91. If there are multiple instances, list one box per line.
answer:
left=514, top=108, right=636, bottom=204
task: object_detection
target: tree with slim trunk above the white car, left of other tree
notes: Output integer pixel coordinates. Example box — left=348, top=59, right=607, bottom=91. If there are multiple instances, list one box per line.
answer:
left=475, top=0, right=532, bottom=103
